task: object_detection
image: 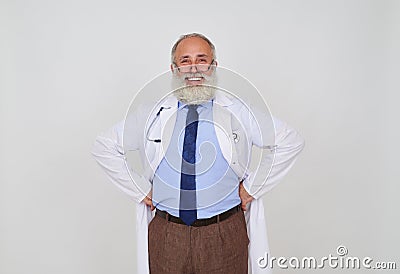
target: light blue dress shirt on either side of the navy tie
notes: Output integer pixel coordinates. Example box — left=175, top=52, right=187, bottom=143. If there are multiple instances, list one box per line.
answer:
left=153, top=101, right=241, bottom=219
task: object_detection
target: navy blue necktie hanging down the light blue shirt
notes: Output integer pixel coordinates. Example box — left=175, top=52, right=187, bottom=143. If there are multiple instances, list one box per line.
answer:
left=179, top=105, right=199, bottom=225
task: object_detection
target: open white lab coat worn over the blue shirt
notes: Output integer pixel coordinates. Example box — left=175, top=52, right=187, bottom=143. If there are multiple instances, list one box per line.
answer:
left=92, top=93, right=304, bottom=274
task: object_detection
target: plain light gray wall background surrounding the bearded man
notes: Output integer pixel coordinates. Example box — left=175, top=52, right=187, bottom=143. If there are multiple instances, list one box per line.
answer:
left=0, top=0, right=400, bottom=274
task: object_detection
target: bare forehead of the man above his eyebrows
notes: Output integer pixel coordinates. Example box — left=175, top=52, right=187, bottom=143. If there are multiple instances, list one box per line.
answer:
left=175, top=37, right=212, bottom=58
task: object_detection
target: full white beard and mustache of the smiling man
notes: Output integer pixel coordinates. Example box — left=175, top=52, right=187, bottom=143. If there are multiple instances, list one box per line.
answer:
left=172, top=72, right=217, bottom=105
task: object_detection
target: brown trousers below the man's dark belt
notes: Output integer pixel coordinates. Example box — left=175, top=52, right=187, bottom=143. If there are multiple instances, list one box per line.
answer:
left=148, top=210, right=249, bottom=274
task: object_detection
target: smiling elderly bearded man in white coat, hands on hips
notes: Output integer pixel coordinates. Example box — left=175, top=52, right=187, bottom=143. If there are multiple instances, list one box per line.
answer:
left=93, top=33, right=304, bottom=274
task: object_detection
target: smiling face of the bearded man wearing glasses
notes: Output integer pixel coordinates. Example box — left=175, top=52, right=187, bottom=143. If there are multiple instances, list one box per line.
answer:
left=171, top=37, right=214, bottom=86
